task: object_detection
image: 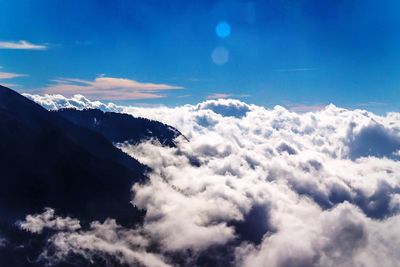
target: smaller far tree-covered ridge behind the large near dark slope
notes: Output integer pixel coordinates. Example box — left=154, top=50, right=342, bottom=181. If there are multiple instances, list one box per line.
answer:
left=55, top=109, right=182, bottom=147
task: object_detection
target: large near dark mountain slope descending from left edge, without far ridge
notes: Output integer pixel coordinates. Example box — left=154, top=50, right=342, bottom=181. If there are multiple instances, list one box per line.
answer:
left=0, top=86, right=147, bottom=223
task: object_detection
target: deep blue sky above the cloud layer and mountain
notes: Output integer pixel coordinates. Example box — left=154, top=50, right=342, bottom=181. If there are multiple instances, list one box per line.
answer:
left=0, top=0, right=400, bottom=112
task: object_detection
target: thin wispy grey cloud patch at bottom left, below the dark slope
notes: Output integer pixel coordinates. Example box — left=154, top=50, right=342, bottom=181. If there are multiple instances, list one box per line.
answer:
left=19, top=209, right=170, bottom=267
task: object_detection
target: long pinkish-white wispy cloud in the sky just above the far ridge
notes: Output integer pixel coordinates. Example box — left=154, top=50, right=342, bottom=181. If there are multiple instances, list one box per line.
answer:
left=42, top=76, right=183, bottom=100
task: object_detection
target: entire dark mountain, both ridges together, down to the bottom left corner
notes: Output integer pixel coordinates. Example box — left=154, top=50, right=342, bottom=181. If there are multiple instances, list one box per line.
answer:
left=0, top=86, right=189, bottom=267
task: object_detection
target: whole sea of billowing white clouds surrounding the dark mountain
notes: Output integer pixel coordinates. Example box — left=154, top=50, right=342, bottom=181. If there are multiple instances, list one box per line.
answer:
left=20, top=94, right=400, bottom=267
